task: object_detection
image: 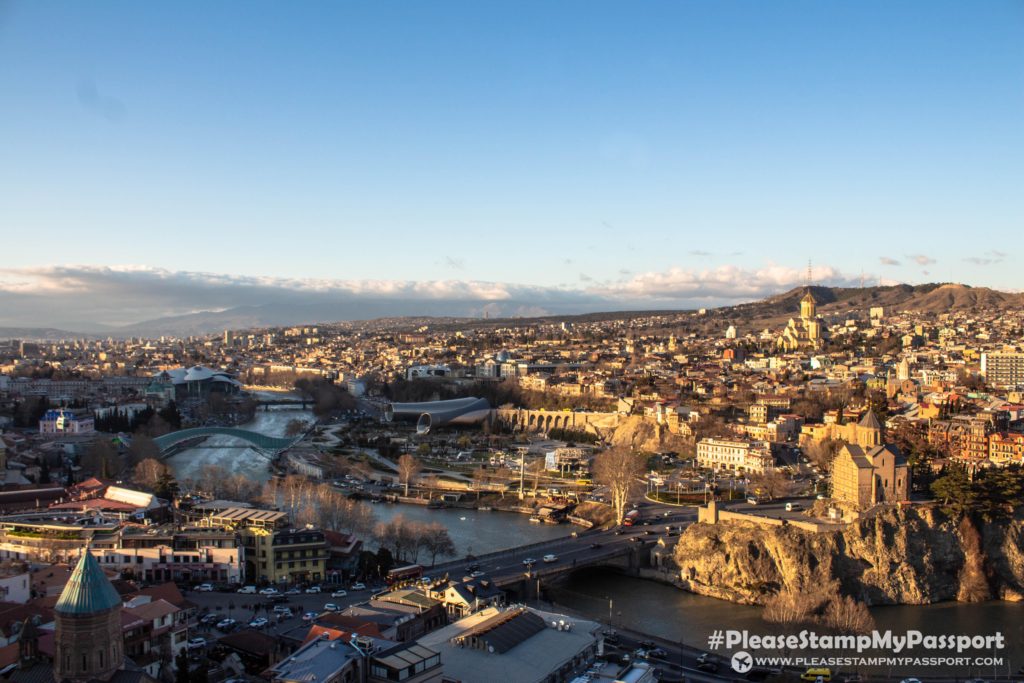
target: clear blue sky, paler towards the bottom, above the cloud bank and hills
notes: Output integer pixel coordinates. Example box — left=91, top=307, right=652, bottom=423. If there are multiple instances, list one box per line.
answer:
left=0, top=0, right=1024, bottom=325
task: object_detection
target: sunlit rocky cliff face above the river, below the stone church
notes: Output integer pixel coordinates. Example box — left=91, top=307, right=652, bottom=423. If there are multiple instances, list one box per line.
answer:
left=676, top=506, right=1024, bottom=604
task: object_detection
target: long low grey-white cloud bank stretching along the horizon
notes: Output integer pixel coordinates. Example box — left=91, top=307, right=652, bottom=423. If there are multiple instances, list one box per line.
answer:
left=0, top=264, right=858, bottom=334
